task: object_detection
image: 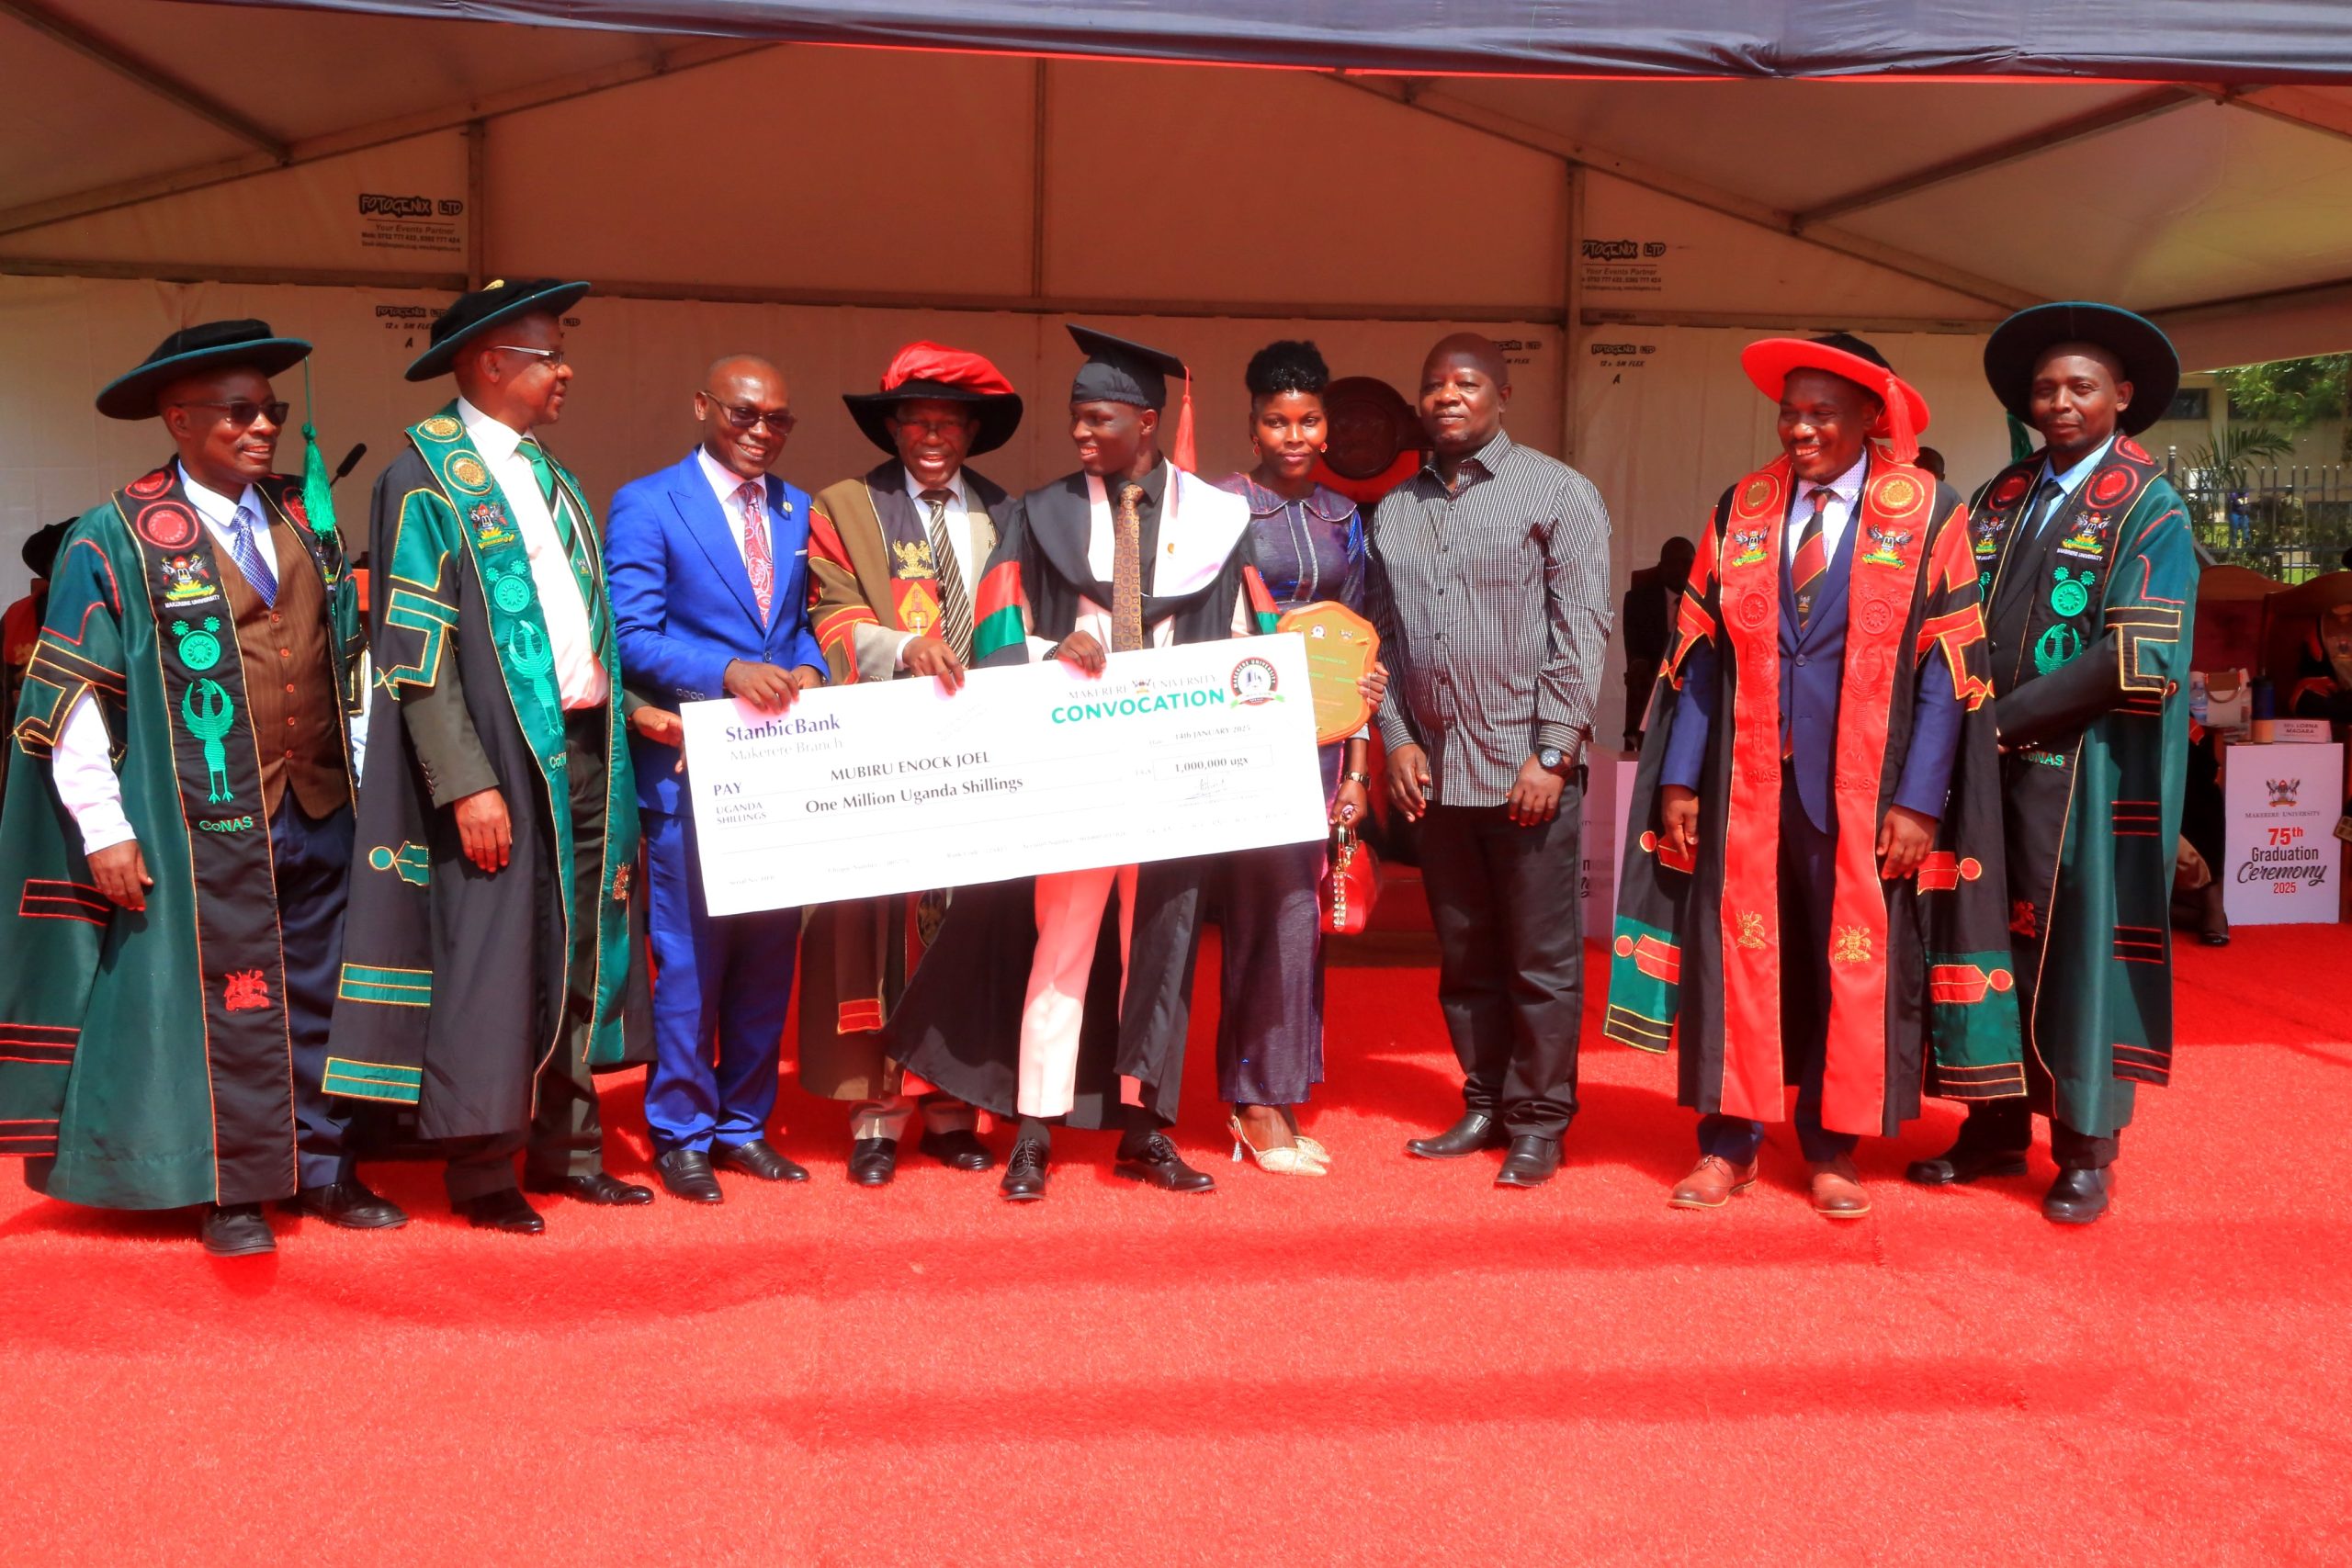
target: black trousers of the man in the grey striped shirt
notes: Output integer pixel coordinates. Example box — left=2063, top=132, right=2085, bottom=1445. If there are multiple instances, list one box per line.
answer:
left=1420, top=799, right=1585, bottom=1138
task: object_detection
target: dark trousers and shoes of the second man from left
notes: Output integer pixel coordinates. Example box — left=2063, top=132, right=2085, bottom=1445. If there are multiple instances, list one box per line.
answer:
left=442, top=707, right=605, bottom=1203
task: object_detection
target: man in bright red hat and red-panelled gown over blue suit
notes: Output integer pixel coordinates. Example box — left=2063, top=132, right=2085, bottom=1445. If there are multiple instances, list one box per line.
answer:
left=1658, top=333, right=1983, bottom=1220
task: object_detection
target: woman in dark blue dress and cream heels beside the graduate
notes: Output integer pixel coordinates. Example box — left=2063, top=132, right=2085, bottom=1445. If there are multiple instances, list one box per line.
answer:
left=1216, top=341, right=1387, bottom=1176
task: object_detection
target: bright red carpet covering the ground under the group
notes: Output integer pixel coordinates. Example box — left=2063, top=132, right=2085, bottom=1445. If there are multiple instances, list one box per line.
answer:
left=0, top=929, right=2352, bottom=1568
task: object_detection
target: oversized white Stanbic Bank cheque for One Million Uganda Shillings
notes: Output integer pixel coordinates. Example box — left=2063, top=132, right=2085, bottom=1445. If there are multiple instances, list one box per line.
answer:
left=682, top=632, right=1327, bottom=915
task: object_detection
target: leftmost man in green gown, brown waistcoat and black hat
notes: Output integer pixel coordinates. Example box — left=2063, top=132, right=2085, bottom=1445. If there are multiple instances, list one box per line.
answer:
left=0, top=320, right=404, bottom=1256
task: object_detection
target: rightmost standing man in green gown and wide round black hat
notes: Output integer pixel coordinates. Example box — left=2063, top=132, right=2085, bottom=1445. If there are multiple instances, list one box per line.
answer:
left=1910, top=303, right=2197, bottom=1224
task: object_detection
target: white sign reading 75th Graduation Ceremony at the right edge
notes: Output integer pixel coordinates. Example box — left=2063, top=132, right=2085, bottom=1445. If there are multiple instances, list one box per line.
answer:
left=2222, top=743, right=2345, bottom=926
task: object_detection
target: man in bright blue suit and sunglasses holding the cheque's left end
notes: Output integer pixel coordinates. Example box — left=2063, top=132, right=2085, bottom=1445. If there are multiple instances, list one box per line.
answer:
left=605, top=355, right=826, bottom=1203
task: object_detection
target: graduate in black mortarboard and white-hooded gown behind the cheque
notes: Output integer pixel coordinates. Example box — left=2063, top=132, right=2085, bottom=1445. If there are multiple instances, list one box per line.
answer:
left=885, top=327, right=1253, bottom=1201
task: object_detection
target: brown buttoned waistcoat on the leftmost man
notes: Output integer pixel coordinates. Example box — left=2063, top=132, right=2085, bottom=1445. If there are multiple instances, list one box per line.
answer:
left=214, top=517, right=350, bottom=818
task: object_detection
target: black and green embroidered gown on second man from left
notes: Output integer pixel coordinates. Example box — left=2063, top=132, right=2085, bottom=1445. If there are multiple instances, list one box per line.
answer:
left=334, top=404, right=638, bottom=1138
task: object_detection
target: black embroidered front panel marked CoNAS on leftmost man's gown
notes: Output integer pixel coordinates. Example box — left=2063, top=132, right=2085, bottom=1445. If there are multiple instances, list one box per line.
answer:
left=113, top=463, right=303, bottom=1203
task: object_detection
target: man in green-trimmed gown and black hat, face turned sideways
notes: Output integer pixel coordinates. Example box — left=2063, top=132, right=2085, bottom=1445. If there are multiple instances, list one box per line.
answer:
left=334, top=277, right=654, bottom=1235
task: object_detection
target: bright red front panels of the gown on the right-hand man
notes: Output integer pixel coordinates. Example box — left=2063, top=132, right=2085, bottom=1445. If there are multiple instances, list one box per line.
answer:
left=1717, top=458, right=1936, bottom=1128
